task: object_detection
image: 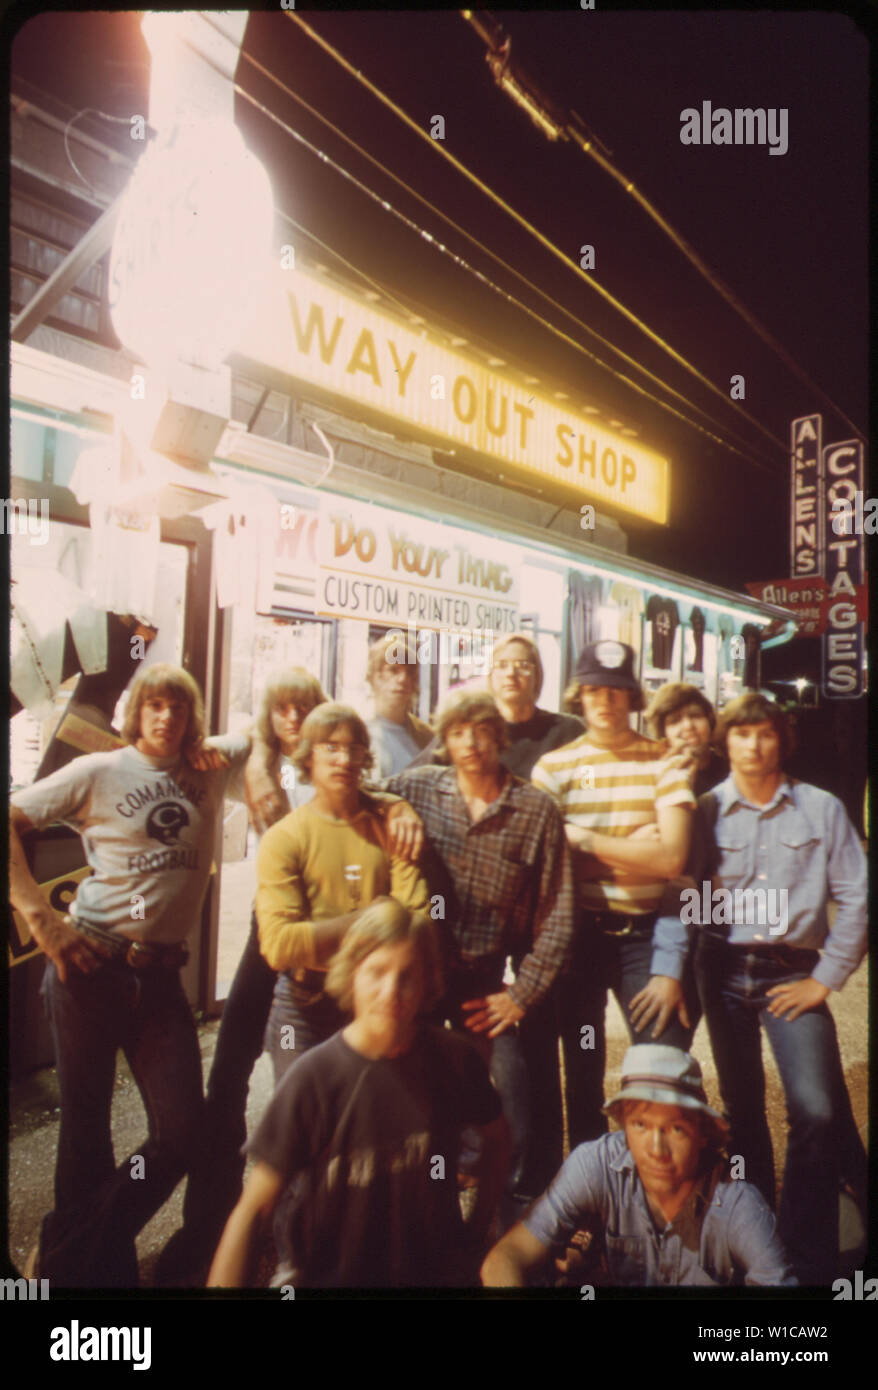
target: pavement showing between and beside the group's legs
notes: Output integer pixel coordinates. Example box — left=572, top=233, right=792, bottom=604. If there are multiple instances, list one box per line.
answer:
left=8, top=950, right=868, bottom=1287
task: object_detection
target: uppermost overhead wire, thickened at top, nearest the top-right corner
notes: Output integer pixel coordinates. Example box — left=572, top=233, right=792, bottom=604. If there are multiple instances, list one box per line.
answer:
left=461, top=10, right=864, bottom=439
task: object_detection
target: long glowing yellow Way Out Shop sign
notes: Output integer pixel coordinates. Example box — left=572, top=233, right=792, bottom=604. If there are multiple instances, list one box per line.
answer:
left=238, top=262, right=670, bottom=523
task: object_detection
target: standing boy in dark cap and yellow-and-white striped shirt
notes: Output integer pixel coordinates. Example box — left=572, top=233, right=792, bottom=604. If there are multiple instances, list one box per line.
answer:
left=532, top=641, right=695, bottom=1145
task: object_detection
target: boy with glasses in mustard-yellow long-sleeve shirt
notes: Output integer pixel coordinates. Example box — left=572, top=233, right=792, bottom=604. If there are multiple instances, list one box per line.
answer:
left=256, top=703, right=429, bottom=1081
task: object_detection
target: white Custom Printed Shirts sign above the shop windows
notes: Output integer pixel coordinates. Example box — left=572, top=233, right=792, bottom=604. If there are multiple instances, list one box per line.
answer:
left=315, top=498, right=521, bottom=632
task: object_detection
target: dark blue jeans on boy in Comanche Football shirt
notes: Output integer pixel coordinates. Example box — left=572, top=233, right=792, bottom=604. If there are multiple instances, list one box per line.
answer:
left=39, top=960, right=204, bottom=1289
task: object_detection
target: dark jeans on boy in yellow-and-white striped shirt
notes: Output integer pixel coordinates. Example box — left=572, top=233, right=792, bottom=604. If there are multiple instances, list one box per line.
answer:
left=560, top=912, right=700, bottom=1150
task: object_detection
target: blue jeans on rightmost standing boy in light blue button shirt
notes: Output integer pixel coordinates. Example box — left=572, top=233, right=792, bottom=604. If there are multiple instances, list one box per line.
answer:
left=696, top=931, right=850, bottom=1284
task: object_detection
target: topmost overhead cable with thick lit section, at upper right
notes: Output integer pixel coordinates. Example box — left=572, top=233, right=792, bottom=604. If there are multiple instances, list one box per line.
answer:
left=461, top=10, right=864, bottom=439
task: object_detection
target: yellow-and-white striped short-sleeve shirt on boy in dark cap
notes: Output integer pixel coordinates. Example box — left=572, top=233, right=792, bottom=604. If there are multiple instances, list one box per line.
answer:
left=531, top=733, right=695, bottom=913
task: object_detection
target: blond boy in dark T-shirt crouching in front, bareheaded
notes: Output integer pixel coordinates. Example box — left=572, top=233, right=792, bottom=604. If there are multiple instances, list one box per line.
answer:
left=208, top=898, right=506, bottom=1287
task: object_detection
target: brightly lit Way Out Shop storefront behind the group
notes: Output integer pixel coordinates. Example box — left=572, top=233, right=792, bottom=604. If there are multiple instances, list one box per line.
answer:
left=13, top=241, right=795, bottom=1059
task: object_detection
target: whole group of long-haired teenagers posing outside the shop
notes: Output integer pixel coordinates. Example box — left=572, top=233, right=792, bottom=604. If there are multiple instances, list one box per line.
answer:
left=10, top=634, right=867, bottom=1287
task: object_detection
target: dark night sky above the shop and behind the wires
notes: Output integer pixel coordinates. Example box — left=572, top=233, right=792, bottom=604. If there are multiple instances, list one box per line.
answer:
left=11, top=7, right=870, bottom=588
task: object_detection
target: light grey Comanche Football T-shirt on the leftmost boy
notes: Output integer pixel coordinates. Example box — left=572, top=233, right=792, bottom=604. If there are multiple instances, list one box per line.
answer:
left=11, top=735, right=250, bottom=944
